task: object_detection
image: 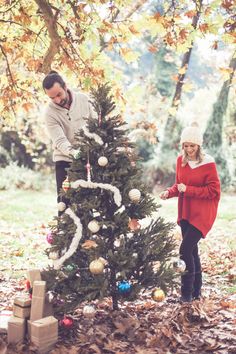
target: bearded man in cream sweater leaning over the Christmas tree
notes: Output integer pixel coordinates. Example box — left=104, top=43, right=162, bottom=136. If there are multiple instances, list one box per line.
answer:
left=43, top=71, right=95, bottom=206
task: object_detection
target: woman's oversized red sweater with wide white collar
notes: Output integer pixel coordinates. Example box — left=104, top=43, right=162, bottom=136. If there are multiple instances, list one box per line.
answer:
left=168, top=155, right=220, bottom=237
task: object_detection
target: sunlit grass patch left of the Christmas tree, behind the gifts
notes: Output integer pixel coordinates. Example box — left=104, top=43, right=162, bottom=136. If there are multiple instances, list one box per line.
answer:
left=0, top=190, right=57, bottom=278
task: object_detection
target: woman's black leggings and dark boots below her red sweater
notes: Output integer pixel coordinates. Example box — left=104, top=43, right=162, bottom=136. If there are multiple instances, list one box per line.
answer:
left=179, top=220, right=202, bottom=297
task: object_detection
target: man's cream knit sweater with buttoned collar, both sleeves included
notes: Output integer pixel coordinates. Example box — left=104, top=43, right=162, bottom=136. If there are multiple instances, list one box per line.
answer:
left=45, top=90, right=96, bottom=161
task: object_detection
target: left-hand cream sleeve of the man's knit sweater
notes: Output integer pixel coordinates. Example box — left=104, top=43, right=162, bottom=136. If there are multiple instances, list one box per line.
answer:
left=46, top=116, right=72, bottom=157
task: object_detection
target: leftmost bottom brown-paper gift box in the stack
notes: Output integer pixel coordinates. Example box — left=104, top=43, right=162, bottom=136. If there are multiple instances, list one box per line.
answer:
left=7, top=316, right=25, bottom=343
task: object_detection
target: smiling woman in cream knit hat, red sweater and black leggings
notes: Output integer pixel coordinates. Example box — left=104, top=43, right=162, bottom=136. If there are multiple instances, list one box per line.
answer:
left=160, top=126, right=220, bottom=302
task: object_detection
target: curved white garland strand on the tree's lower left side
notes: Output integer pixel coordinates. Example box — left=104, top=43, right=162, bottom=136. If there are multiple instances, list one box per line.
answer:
left=53, top=208, right=83, bottom=270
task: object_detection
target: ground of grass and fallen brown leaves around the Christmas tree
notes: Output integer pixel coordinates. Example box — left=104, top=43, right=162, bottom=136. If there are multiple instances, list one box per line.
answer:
left=0, top=195, right=236, bottom=354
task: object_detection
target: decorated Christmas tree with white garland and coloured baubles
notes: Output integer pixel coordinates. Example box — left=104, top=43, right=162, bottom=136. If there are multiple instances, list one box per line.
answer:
left=43, top=85, right=175, bottom=312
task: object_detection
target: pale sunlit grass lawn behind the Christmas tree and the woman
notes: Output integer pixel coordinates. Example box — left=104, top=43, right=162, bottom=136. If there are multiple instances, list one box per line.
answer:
left=0, top=190, right=236, bottom=292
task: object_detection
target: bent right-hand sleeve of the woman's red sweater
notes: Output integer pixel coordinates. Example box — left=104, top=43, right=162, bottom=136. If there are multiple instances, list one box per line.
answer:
left=184, top=163, right=220, bottom=199
